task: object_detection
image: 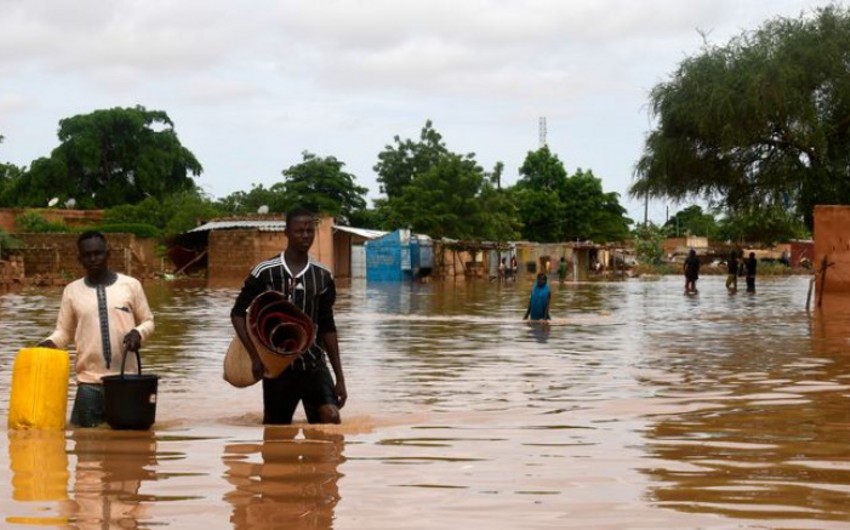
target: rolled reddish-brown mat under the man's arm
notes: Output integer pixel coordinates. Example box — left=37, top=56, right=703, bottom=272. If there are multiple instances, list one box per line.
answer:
left=224, top=291, right=315, bottom=387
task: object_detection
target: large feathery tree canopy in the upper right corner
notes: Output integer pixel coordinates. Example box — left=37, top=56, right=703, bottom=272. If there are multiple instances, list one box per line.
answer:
left=629, top=6, right=850, bottom=227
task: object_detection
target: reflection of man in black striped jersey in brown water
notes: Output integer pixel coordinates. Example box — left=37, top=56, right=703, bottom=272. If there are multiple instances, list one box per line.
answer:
left=223, top=426, right=345, bottom=530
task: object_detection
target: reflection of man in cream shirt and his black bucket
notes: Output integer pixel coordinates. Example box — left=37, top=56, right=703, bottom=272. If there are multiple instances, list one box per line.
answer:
left=69, top=429, right=157, bottom=529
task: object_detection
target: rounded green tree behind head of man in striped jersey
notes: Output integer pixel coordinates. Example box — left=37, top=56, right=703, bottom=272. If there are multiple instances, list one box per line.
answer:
left=283, top=151, right=369, bottom=223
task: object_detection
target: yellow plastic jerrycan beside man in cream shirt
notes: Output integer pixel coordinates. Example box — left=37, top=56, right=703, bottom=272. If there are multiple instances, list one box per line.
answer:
left=8, top=348, right=70, bottom=430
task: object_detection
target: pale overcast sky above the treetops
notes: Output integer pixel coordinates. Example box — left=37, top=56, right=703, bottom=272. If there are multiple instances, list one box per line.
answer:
left=0, top=0, right=827, bottom=222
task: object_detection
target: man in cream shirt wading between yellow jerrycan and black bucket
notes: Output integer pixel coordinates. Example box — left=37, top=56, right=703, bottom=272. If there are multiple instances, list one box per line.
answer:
left=39, top=231, right=154, bottom=427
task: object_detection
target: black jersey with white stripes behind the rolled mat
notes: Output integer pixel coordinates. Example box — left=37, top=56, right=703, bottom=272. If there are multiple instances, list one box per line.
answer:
left=230, top=252, right=336, bottom=369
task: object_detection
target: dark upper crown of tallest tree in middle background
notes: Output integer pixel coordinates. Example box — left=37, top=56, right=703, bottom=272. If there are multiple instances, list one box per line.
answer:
left=373, top=120, right=454, bottom=199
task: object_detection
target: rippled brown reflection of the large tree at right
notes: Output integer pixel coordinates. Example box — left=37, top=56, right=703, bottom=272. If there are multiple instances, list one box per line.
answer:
left=645, top=280, right=850, bottom=528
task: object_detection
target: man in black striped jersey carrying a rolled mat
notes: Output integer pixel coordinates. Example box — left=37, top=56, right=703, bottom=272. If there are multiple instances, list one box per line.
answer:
left=230, top=209, right=348, bottom=424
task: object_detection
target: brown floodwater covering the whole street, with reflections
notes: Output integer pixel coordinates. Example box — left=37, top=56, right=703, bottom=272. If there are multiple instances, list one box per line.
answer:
left=0, top=276, right=850, bottom=530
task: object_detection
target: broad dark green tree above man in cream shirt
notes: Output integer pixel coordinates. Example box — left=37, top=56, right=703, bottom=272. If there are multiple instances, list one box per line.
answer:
left=8, top=106, right=202, bottom=208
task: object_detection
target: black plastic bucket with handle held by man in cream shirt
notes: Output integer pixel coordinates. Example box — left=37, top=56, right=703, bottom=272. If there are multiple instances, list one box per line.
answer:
left=101, top=350, right=159, bottom=431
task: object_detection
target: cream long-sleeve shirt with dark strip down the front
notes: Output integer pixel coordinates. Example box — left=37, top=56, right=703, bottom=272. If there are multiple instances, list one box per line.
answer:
left=48, top=274, right=154, bottom=383
